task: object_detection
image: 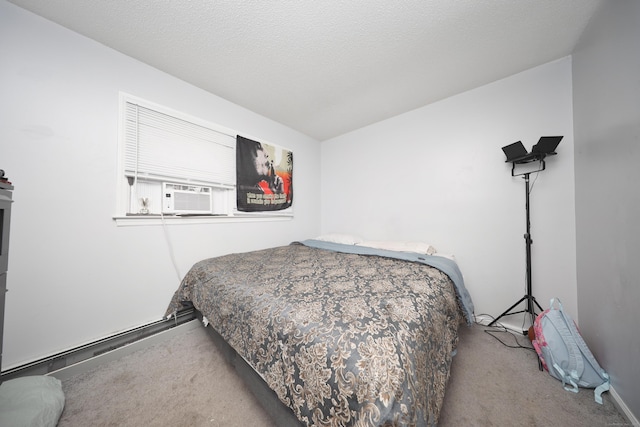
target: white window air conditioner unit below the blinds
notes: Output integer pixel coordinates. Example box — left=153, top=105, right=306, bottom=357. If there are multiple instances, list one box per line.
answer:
left=162, top=182, right=213, bottom=214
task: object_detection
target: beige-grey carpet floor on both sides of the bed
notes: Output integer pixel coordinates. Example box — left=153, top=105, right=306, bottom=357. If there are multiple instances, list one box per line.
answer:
left=58, top=325, right=629, bottom=427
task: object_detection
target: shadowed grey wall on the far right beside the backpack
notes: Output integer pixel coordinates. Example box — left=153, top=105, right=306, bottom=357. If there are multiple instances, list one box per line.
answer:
left=573, top=0, right=640, bottom=421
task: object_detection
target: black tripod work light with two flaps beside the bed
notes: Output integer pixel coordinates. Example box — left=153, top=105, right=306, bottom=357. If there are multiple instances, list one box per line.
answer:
left=489, top=136, right=563, bottom=335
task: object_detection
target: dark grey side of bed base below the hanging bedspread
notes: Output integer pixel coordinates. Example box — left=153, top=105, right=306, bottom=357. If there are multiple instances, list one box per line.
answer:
left=196, top=310, right=304, bottom=427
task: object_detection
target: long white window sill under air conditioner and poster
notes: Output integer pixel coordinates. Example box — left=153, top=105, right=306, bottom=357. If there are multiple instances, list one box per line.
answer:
left=113, top=213, right=293, bottom=227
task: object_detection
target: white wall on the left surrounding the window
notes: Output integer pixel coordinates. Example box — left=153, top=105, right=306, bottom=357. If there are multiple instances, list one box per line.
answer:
left=0, top=0, right=320, bottom=369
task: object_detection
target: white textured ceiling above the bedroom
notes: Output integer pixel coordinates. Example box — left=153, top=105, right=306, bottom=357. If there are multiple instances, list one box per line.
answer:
left=10, top=0, right=603, bottom=141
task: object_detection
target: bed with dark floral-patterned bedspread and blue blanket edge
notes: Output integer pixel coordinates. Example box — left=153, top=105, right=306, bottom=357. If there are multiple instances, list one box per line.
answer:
left=167, top=240, right=473, bottom=427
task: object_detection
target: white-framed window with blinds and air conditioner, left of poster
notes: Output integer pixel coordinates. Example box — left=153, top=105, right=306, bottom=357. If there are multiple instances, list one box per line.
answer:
left=116, top=93, right=291, bottom=223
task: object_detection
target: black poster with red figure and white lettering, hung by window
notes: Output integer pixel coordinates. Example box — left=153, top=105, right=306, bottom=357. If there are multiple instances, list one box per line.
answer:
left=236, top=135, right=293, bottom=212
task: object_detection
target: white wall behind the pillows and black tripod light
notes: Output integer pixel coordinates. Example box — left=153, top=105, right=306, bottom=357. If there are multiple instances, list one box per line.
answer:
left=321, top=58, right=577, bottom=326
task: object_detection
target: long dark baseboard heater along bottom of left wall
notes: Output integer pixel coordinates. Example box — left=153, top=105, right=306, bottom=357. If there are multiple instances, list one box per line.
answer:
left=0, top=308, right=196, bottom=381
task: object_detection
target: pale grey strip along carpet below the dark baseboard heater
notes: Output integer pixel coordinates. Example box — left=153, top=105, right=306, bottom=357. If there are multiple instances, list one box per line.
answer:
left=46, top=319, right=200, bottom=381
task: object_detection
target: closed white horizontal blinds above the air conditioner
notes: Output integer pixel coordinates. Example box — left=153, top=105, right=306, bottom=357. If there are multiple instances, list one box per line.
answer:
left=124, top=100, right=236, bottom=186
